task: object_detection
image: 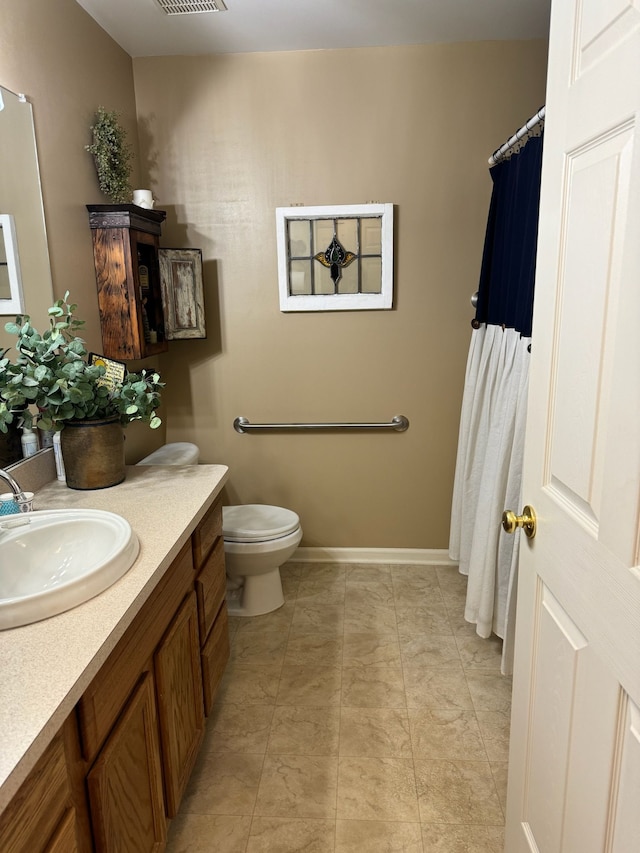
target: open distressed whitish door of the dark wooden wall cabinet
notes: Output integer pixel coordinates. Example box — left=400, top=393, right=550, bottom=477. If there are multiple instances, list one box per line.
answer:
left=158, top=249, right=207, bottom=341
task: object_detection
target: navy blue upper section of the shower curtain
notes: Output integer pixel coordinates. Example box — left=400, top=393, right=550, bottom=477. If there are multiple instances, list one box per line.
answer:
left=476, top=136, right=542, bottom=337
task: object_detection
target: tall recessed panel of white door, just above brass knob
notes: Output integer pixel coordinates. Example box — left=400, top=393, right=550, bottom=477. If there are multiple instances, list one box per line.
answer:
left=547, top=127, right=632, bottom=535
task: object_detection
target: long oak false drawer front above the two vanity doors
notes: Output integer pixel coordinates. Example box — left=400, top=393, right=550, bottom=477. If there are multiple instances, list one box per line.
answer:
left=77, top=542, right=193, bottom=761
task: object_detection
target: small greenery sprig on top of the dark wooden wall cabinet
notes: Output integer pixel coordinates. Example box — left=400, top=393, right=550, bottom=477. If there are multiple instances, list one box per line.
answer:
left=85, top=107, right=133, bottom=204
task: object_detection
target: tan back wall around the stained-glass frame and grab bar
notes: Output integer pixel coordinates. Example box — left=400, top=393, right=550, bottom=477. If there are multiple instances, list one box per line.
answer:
left=134, top=42, right=546, bottom=548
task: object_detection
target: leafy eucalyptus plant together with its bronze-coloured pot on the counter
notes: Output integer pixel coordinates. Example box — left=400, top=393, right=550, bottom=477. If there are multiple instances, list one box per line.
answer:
left=0, top=292, right=164, bottom=488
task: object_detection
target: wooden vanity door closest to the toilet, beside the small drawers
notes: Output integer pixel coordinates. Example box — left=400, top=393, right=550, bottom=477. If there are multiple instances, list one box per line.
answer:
left=154, top=592, right=204, bottom=818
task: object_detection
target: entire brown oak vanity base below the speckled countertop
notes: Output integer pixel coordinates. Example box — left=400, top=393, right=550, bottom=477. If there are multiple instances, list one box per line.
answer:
left=0, top=500, right=229, bottom=853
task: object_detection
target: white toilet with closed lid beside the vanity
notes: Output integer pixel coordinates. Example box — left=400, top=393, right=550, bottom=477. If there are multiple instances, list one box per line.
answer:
left=138, top=441, right=302, bottom=616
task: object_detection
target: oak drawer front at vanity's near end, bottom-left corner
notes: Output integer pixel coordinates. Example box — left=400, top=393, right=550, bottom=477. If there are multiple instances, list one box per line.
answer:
left=0, top=734, right=71, bottom=853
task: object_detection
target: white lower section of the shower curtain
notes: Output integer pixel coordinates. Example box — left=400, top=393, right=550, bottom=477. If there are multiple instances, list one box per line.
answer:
left=449, top=325, right=531, bottom=675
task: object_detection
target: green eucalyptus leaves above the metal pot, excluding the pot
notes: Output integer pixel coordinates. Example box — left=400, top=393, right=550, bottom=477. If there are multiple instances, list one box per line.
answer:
left=0, top=292, right=164, bottom=432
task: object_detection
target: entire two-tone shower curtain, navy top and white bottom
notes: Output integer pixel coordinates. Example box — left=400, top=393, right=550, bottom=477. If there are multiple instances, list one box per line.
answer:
left=449, top=135, right=542, bottom=675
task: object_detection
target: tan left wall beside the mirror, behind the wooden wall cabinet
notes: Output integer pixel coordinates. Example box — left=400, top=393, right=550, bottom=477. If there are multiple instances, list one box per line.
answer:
left=0, top=0, right=165, bottom=459
